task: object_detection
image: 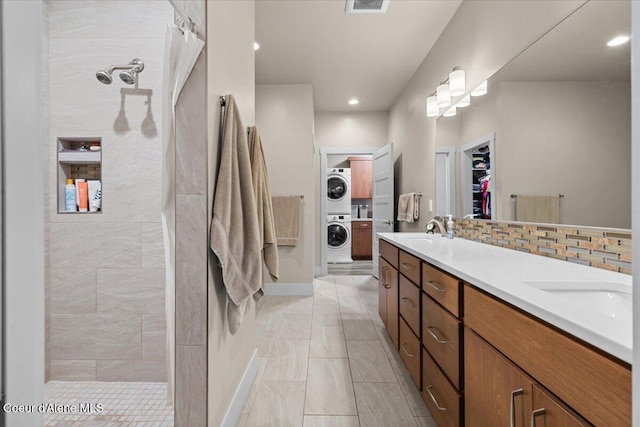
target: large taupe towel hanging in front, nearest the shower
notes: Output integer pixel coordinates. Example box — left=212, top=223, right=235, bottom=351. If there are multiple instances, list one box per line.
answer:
left=210, top=95, right=262, bottom=334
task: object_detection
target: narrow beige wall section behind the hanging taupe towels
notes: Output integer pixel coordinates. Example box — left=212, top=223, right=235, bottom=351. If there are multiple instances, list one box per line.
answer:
left=206, top=0, right=257, bottom=426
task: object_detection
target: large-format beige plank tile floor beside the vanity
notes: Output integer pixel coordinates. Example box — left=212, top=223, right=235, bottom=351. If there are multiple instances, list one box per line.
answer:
left=238, top=275, right=436, bottom=427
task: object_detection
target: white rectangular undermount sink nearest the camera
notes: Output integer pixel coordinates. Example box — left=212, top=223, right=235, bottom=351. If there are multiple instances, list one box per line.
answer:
left=523, top=280, right=633, bottom=322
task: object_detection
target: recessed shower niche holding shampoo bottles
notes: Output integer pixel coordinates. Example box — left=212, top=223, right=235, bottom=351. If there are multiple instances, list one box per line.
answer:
left=57, top=137, right=102, bottom=214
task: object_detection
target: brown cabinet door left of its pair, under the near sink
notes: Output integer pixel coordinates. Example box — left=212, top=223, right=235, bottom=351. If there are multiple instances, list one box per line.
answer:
left=464, top=328, right=533, bottom=427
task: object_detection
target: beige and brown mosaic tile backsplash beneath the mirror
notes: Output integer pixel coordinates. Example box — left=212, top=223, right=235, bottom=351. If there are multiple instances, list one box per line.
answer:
left=455, top=219, right=631, bottom=274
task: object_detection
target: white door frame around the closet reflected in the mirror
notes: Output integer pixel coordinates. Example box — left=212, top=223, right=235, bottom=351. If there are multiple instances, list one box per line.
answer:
left=460, top=132, right=498, bottom=220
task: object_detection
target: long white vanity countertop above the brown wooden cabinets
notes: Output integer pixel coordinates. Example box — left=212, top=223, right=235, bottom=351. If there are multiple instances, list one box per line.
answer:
left=378, top=233, right=632, bottom=364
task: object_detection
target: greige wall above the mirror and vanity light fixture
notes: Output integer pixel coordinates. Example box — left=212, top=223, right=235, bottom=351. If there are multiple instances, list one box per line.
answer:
left=388, top=1, right=583, bottom=231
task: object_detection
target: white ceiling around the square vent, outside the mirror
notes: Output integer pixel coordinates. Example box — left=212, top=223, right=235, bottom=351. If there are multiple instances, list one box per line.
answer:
left=256, top=0, right=462, bottom=111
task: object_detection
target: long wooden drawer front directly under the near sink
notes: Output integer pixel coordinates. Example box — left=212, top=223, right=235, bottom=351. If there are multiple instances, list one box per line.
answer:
left=464, top=285, right=631, bottom=427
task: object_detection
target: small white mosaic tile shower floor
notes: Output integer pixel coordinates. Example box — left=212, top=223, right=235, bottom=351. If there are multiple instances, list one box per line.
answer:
left=44, top=381, right=173, bottom=427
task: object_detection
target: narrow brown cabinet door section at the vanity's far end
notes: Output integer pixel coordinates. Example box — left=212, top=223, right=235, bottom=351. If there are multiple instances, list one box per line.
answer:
left=378, top=257, right=398, bottom=349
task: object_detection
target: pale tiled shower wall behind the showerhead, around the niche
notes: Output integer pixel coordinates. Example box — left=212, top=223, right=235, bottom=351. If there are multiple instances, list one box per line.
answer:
left=45, top=0, right=173, bottom=381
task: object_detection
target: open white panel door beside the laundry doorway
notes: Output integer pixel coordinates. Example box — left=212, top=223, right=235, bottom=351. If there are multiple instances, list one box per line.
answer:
left=371, top=142, right=394, bottom=277
